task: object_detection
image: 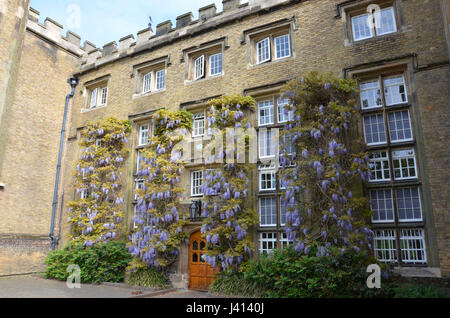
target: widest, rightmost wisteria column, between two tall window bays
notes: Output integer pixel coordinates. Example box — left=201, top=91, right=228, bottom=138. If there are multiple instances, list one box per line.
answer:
left=281, top=72, right=373, bottom=255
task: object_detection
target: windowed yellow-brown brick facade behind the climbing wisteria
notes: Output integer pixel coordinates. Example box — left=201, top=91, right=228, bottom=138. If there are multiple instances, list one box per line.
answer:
left=0, top=0, right=450, bottom=287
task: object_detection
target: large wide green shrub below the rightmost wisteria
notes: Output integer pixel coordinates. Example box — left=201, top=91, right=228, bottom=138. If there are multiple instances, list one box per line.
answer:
left=211, top=249, right=393, bottom=298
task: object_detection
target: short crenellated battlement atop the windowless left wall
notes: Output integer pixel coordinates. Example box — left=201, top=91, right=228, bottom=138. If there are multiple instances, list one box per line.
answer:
left=27, top=8, right=96, bottom=57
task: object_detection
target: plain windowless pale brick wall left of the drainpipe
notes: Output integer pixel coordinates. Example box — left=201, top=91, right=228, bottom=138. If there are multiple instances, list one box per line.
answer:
left=0, top=6, right=78, bottom=275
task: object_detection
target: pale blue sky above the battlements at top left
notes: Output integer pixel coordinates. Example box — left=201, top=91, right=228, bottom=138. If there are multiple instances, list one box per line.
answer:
left=31, top=0, right=246, bottom=47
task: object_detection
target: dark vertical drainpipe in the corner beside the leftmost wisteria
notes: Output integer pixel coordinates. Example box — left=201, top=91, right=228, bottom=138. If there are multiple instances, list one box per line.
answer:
left=49, top=77, right=78, bottom=251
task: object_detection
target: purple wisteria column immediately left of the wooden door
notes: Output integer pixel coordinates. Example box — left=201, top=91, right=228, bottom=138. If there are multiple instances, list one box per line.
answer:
left=129, top=110, right=192, bottom=271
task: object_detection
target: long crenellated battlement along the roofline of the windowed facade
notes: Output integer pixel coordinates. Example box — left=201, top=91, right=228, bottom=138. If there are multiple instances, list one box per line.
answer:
left=79, top=0, right=292, bottom=72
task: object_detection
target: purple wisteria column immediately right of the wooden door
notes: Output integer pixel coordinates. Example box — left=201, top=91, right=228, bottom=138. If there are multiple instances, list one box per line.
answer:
left=202, top=96, right=257, bottom=272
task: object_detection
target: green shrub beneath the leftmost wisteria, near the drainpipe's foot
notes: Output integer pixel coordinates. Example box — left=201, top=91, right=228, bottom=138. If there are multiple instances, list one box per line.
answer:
left=45, top=242, right=132, bottom=283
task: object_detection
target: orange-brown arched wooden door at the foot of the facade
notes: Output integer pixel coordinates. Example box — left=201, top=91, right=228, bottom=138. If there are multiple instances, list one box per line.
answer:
left=189, top=231, right=216, bottom=290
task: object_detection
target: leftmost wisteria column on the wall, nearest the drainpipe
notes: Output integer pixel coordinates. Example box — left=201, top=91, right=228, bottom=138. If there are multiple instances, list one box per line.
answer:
left=68, top=117, right=130, bottom=247
